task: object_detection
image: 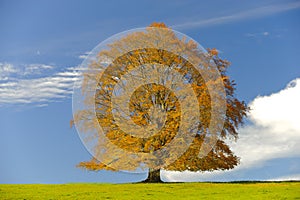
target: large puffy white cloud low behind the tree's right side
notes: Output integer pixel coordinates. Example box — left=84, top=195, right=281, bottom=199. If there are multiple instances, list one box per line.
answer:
left=163, top=78, right=300, bottom=181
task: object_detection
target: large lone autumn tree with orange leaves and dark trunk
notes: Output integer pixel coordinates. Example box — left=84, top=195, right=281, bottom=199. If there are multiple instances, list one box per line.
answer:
left=74, top=23, right=249, bottom=182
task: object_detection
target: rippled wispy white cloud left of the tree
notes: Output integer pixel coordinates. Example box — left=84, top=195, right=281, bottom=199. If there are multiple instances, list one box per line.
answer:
left=0, top=63, right=81, bottom=107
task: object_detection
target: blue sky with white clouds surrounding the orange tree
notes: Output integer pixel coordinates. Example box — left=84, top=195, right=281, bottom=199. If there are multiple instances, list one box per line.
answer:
left=0, top=0, right=300, bottom=183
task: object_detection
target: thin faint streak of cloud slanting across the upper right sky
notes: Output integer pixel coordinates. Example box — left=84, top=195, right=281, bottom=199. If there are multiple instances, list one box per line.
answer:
left=171, top=1, right=300, bottom=29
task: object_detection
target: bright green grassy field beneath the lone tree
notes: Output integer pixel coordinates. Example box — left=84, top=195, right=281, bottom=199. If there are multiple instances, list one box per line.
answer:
left=0, top=182, right=300, bottom=200
